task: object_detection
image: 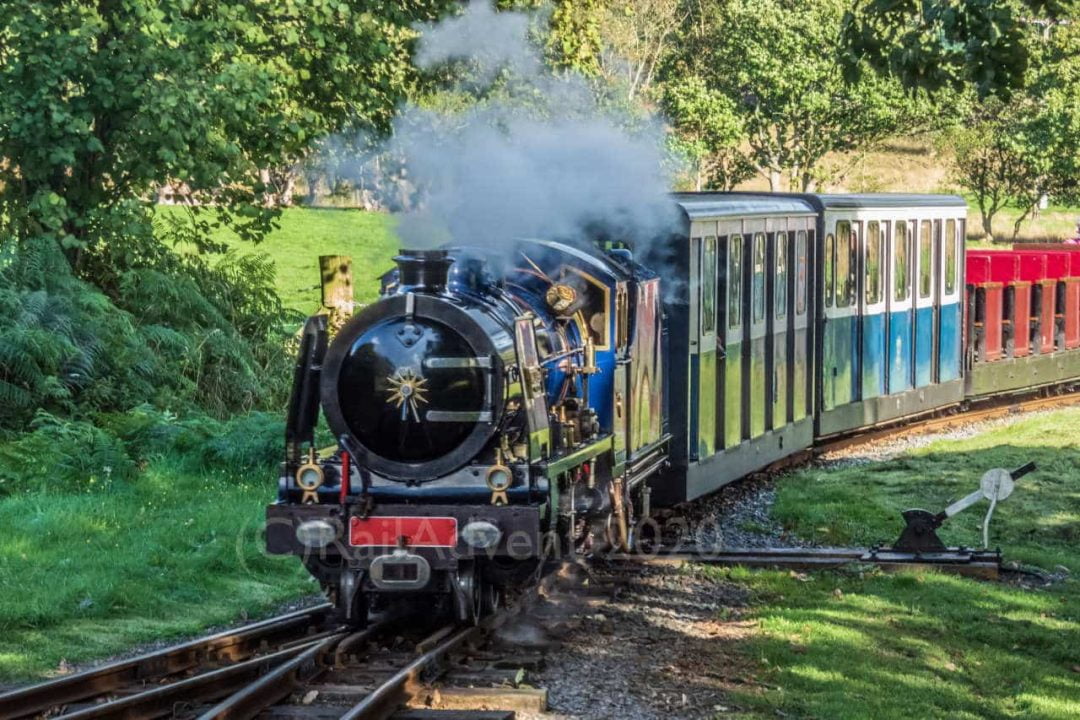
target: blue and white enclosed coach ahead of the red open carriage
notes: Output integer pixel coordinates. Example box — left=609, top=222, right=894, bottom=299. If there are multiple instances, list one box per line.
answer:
left=805, top=194, right=968, bottom=436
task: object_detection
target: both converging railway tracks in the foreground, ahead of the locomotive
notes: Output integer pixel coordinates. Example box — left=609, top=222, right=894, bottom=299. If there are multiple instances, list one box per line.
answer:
left=0, top=606, right=546, bottom=720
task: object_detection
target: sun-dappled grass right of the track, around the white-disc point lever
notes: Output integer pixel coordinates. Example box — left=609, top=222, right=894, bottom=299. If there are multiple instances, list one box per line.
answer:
left=717, top=409, right=1080, bottom=720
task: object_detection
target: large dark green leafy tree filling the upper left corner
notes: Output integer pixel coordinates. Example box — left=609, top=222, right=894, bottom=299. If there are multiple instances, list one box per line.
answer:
left=0, top=0, right=450, bottom=271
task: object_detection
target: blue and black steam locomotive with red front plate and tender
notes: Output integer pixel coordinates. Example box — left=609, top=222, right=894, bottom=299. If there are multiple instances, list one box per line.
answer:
left=267, top=241, right=667, bottom=624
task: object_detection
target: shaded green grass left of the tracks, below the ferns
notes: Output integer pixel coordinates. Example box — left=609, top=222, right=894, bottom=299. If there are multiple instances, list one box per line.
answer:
left=0, top=460, right=319, bottom=681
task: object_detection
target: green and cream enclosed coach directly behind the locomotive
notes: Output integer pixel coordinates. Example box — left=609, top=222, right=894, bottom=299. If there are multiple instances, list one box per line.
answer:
left=653, top=193, right=819, bottom=503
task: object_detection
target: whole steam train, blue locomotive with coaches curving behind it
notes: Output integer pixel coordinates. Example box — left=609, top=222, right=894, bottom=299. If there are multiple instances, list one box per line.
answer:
left=267, top=193, right=1080, bottom=624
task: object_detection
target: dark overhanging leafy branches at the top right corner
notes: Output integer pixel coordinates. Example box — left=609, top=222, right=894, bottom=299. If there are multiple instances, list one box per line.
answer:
left=843, top=0, right=1078, bottom=98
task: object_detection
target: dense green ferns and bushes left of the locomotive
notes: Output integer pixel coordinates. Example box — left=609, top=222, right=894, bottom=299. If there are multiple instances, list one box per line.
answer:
left=0, top=216, right=298, bottom=432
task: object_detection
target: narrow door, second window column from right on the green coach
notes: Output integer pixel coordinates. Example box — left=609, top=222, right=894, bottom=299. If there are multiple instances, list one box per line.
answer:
left=767, top=226, right=792, bottom=429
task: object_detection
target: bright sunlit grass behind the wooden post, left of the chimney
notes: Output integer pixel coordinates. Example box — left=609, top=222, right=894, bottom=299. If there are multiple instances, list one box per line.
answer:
left=158, top=206, right=399, bottom=314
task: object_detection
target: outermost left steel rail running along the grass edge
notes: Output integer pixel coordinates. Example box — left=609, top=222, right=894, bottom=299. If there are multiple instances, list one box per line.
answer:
left=0, top=603, right=330, bottom=720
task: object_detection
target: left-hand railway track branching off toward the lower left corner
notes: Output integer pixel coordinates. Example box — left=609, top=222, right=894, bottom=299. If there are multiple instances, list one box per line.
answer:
left=0, top=603, right=330, bottom=720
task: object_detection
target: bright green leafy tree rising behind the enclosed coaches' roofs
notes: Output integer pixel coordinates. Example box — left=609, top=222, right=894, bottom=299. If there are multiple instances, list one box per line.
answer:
left=666, top=0, right=930, bottom=191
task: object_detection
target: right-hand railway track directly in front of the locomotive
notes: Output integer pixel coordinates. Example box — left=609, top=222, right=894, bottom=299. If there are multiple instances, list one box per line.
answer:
left=190, top=610, right=548, bottom=720
